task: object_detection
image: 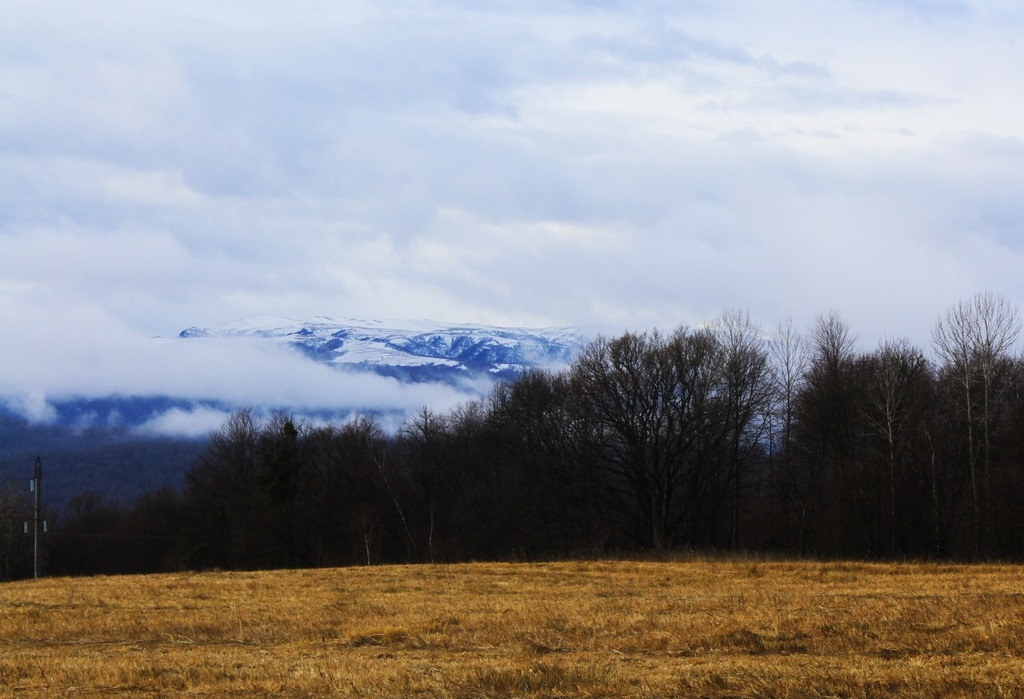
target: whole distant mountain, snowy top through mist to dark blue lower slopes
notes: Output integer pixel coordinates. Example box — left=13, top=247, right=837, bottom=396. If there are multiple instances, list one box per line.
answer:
left=0, top=317, right=586, bottom=506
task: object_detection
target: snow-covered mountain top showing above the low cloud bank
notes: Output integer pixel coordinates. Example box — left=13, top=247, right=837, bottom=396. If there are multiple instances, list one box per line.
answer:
left=178, top=317, right=587, bottom=383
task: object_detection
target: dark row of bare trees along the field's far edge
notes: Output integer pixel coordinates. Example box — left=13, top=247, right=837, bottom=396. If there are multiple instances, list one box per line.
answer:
left=0, top=294, right=1024, bottom=573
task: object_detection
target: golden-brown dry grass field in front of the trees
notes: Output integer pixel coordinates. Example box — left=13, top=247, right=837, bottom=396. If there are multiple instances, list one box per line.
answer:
left=0, top=561, right=1024, bottom=699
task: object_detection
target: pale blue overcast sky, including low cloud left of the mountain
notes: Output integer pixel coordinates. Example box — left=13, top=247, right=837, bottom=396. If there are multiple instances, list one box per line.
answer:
left=0, top=0, right=1024, bottom=431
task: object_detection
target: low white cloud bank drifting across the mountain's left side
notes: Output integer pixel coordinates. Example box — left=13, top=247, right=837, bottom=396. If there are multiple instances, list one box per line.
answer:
left=0, top=286, right=474, bottom=431
